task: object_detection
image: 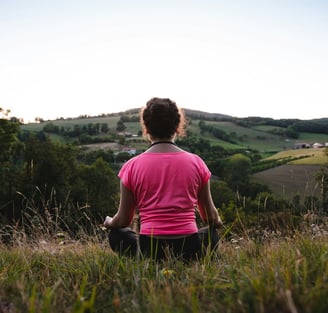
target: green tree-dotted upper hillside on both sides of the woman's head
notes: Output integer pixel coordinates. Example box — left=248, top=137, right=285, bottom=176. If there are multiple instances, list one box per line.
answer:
left=21, top=109, right=328, bottom=156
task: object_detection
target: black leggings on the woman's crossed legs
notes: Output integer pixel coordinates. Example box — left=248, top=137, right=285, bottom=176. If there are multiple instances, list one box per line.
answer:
left=108, top=227, right=219, bottom=261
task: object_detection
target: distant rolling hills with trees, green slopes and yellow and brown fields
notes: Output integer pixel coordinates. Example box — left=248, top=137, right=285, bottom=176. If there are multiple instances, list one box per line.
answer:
left=21, top=108, right=328, bottom=199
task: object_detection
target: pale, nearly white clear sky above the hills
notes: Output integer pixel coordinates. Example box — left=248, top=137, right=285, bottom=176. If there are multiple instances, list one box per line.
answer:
left=0, top=0, right=328, bottom=122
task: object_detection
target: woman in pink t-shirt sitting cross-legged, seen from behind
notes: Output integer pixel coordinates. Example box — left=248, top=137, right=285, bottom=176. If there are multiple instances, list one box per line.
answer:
left=104, top=98, right=222, bottom=260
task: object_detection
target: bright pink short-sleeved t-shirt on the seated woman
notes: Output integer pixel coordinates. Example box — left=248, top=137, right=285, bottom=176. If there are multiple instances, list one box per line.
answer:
left=118, top=151, right=211, bottom=235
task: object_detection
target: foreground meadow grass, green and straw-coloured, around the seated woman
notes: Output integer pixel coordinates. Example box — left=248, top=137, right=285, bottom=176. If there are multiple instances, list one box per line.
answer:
left=0, top=216, right=328, bottom=313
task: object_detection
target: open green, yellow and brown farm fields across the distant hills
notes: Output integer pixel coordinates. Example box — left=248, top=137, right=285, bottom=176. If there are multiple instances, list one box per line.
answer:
left=21, top=109, right=328, bottom=198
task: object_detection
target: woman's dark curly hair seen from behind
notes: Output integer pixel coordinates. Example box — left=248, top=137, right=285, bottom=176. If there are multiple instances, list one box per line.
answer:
left=140, top=98, right=185, bottom=139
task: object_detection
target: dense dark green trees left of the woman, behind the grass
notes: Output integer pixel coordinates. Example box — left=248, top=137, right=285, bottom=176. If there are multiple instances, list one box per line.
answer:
left=0, top=134, right=118, bottom=224
